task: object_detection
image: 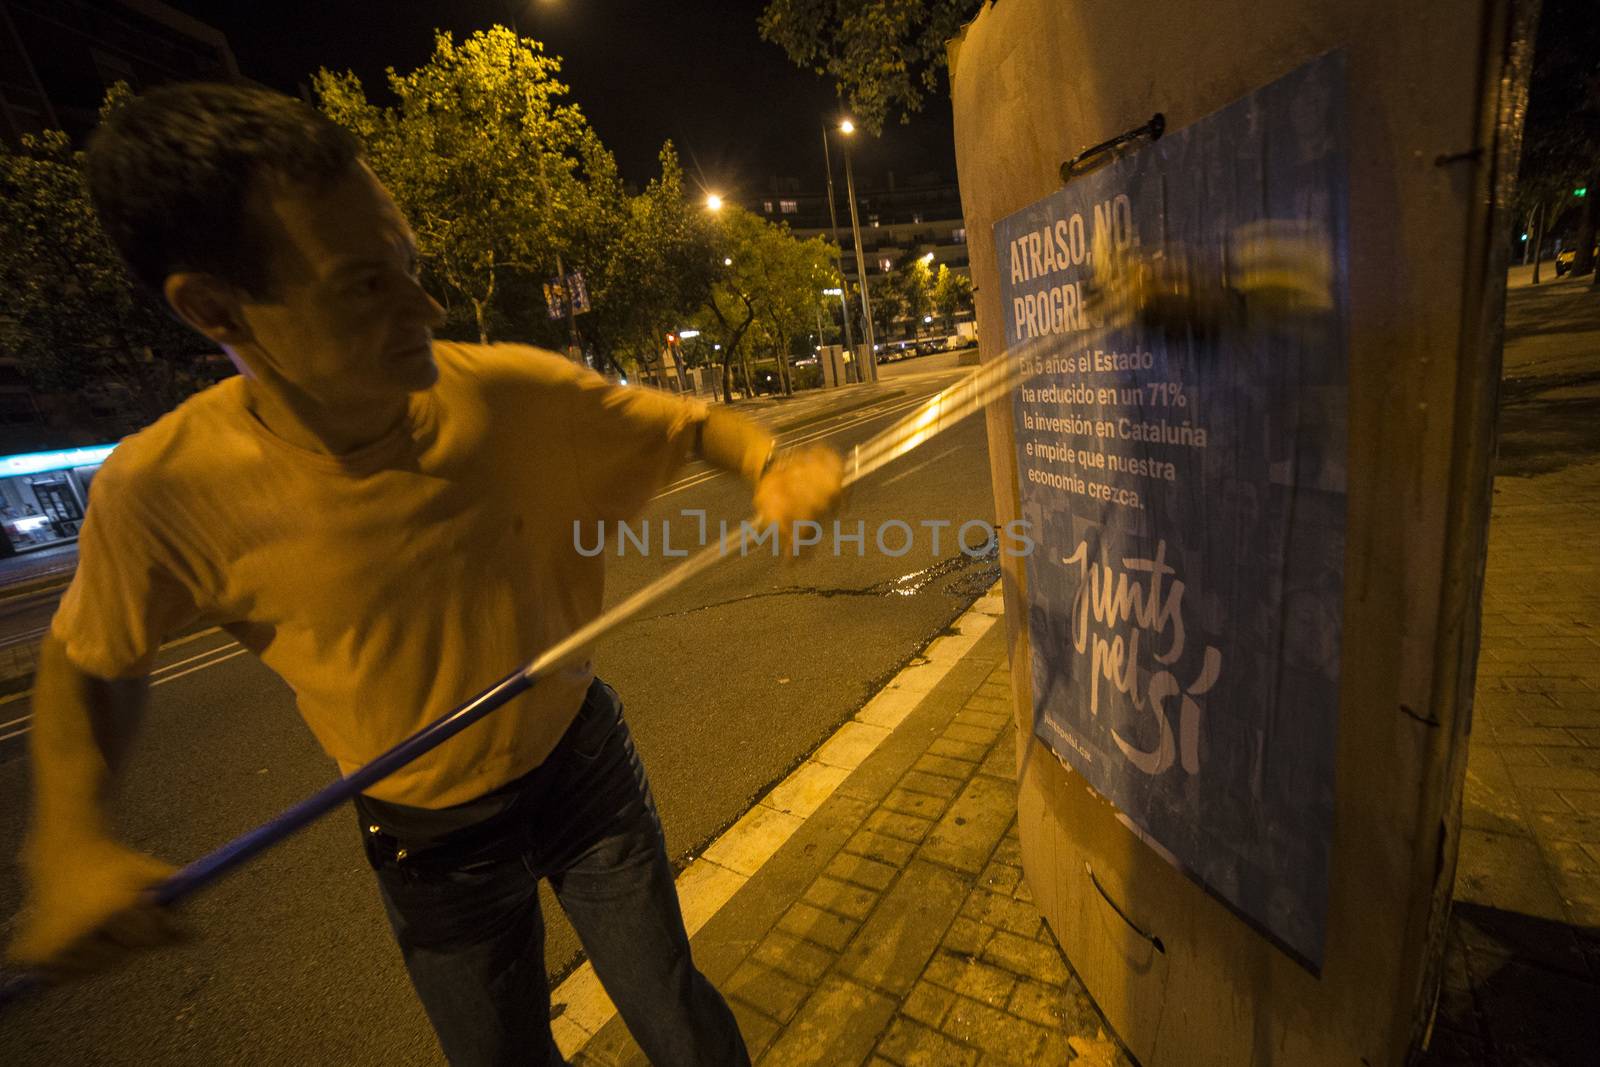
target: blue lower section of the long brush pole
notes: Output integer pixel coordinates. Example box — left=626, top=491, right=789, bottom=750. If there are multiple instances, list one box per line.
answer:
left=0, top=667, right=536, bottom=1008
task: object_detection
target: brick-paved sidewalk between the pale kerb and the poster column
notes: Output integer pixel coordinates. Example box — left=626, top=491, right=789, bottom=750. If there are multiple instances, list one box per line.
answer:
left=569, top=597, right=1131, bottom=1067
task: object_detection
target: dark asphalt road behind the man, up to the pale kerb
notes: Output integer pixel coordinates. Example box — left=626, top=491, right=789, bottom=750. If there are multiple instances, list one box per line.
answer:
left=0, top=357, right=998, bottom=1064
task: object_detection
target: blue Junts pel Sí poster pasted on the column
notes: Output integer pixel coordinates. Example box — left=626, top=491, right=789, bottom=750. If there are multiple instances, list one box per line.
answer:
left=994, top=53, right=1349, bottom=971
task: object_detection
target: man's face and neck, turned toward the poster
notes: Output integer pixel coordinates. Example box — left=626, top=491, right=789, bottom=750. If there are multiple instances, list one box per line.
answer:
left=238, top=163, right=443, bottom=408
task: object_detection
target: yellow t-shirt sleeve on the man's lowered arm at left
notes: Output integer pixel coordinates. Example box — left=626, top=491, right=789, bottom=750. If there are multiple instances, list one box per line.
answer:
left=50, top=453, right=200, bottom=678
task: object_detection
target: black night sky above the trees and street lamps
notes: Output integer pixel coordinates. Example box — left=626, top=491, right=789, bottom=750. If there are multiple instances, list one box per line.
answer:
left=166, top=0, right=955, bottom=197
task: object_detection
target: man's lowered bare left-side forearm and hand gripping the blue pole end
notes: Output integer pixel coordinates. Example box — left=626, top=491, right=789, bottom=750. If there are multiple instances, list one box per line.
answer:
left=6, top=635, right=174, bottom=974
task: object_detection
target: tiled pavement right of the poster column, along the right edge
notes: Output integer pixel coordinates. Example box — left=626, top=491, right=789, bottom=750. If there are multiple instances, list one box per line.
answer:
left=1426, top=460, right=1600, bottom=1065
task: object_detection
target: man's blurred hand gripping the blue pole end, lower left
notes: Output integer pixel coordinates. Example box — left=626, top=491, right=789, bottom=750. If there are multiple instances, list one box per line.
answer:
left=6, top=837, right=179, bottom=977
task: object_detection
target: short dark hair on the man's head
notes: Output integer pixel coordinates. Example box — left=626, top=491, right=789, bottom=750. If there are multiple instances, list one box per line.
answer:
left=88, top=83, right=362, bottom=298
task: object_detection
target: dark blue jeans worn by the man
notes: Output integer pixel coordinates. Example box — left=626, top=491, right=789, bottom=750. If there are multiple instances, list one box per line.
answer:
left=357, top=680, right=750, bottom=1067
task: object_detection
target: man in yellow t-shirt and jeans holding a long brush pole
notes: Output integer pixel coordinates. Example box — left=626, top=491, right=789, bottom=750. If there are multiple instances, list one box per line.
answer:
left=10, top=85, right=840, bottom=1064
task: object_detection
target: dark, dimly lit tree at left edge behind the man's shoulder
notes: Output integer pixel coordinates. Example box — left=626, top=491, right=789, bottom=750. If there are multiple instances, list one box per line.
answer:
left=0, top=90, right=216, bottom=429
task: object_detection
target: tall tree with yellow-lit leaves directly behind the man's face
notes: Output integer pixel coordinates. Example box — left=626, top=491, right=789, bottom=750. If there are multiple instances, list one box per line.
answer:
left=314, top=26, right=595, bottom=342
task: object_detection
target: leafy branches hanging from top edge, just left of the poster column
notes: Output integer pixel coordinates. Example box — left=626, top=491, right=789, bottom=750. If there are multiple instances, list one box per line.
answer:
left=760, top=0, right=984, bottom=133
